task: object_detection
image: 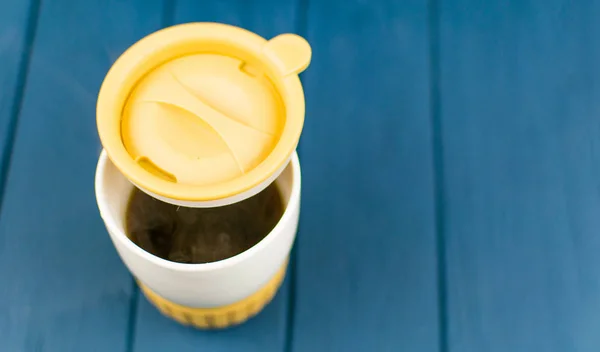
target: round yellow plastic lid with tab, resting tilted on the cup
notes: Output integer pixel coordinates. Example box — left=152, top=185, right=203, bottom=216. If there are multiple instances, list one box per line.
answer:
left=97, top=23, right=311, bottom=202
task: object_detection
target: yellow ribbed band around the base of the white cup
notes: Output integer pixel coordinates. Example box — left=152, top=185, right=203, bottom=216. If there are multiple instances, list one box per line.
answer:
left=138, top=261, right=287, bottom=329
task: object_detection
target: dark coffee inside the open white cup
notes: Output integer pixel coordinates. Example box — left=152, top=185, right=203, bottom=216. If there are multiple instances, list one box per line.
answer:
left=126, top=184, right=284, bottom=263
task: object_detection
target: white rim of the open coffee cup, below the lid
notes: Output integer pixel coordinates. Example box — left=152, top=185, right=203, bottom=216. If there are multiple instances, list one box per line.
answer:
left=94, top=150, right=301, bottom=272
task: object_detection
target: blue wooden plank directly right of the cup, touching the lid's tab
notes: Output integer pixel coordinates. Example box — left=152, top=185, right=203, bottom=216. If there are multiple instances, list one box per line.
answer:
left=292, top=0, right=439, bottom=351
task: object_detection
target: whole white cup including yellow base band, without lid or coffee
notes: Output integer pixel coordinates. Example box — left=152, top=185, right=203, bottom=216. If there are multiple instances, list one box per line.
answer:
left=96, top=151, right=301, bottom=328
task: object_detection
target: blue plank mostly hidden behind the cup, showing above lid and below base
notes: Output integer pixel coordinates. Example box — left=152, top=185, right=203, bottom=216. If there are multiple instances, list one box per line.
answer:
left=134, top=0, right=297, bottom=352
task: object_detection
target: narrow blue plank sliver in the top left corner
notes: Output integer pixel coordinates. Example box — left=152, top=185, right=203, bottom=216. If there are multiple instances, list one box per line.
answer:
left=0, top=0, right=38, bottom=205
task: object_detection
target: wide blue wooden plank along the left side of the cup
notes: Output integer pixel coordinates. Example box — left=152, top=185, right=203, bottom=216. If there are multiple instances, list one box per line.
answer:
left=0, top=0, right=162, bottom=352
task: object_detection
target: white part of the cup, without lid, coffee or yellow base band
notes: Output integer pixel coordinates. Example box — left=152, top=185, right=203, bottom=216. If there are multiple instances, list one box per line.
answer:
left=96, top=151, right=300, bottom=308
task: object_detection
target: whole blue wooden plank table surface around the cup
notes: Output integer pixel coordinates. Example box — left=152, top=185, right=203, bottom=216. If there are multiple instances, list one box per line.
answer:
left=0, top=0, right=600, bottom=352
